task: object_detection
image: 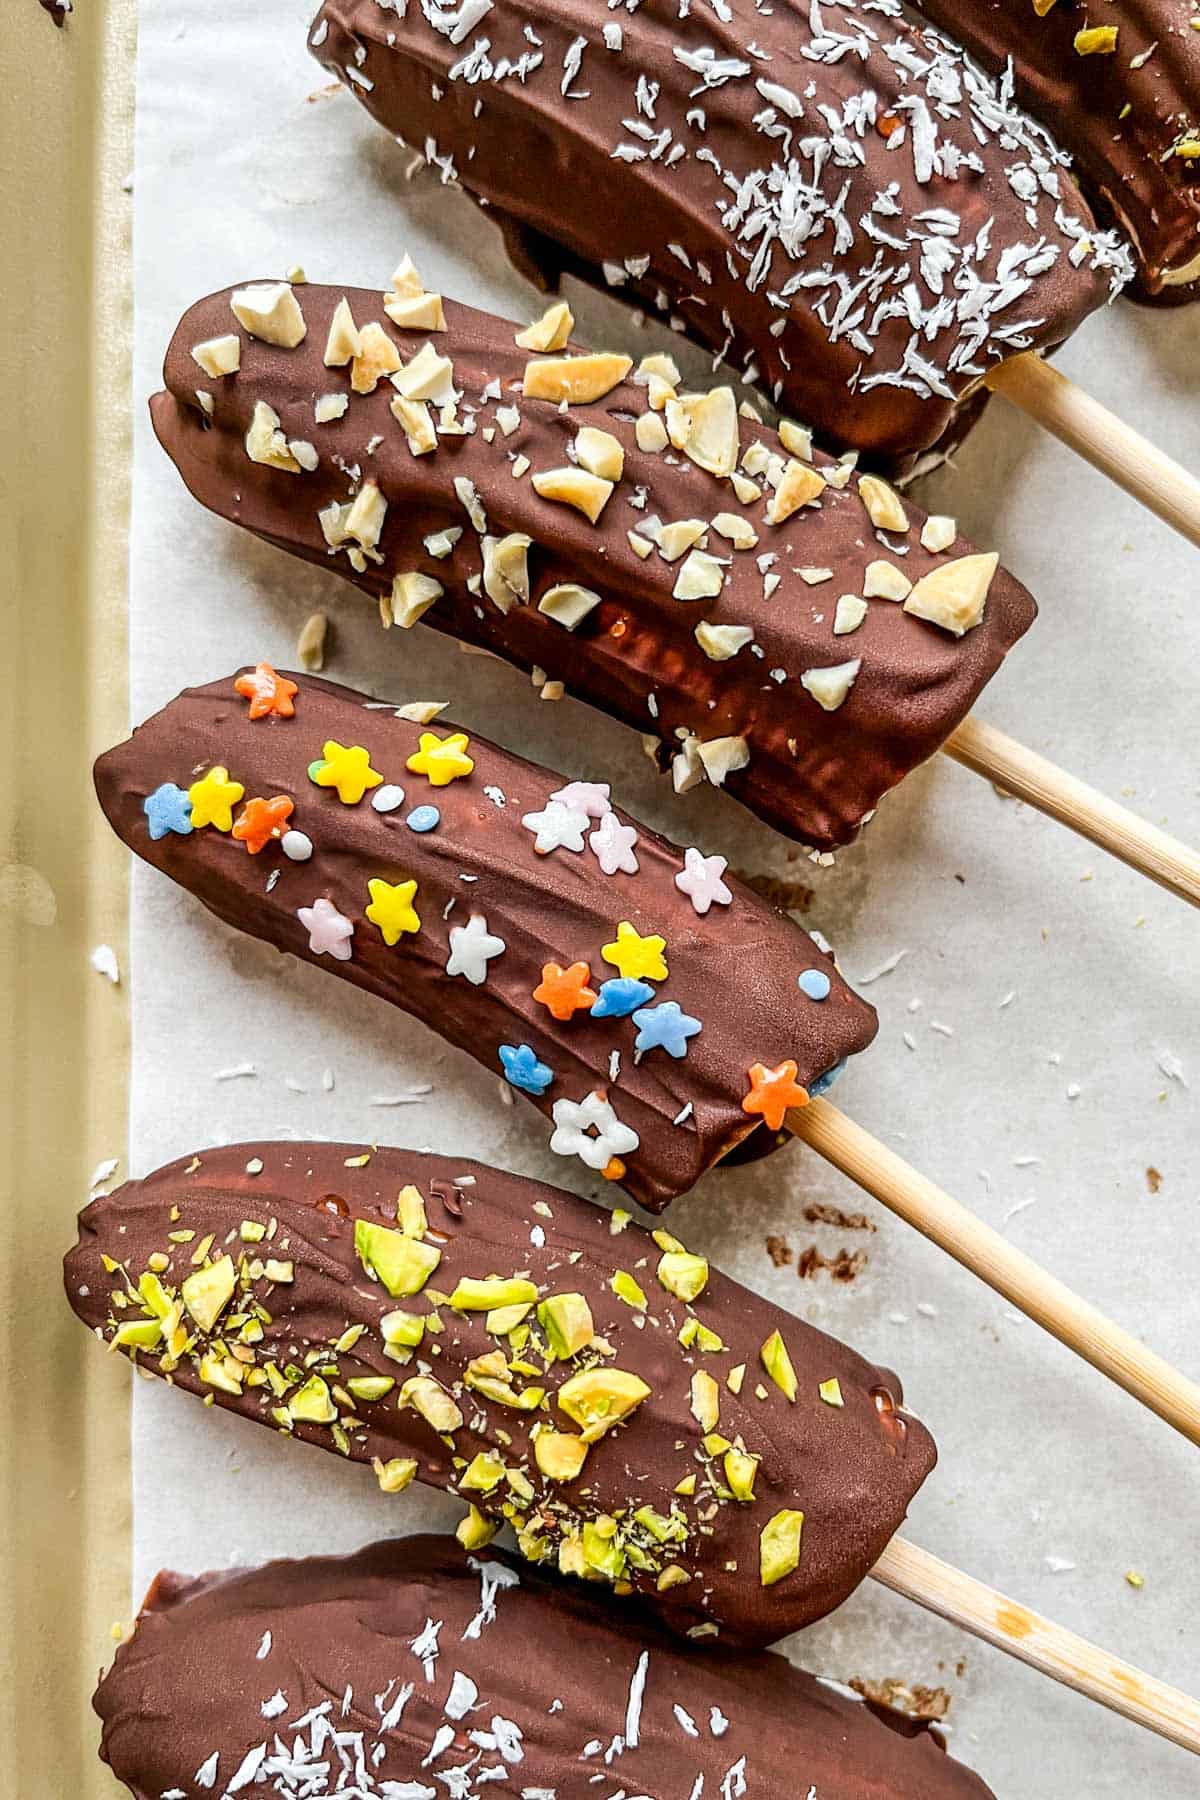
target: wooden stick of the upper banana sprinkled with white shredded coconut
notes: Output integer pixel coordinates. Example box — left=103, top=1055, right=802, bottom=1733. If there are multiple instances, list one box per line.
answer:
left=984, top=351, right=1200, bottom=544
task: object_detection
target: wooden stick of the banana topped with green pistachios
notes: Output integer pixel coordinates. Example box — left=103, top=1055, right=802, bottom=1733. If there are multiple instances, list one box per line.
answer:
left=871, top=1537, right=1200, bottom=1755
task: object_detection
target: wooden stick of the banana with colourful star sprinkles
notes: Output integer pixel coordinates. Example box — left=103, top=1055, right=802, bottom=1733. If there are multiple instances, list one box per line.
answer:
left=786, top=1100, right=1200, bottom=1444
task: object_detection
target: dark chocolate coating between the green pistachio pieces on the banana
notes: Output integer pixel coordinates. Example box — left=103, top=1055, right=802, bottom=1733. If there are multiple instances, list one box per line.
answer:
left=65, top=1143, right=936, bottom=1645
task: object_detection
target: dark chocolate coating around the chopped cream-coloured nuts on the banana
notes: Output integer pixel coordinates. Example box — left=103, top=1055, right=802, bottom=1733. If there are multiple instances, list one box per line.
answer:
left=151, top=284, right=1036, bottom=850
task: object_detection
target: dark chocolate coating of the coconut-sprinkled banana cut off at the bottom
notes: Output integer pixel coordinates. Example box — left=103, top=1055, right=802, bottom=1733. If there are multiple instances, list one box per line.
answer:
left=94, top=1537, right=991, bottom=1800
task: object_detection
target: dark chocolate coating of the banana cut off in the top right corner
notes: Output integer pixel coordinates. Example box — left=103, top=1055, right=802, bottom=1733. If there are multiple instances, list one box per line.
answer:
left=916, top=0, right=1200, bottom=302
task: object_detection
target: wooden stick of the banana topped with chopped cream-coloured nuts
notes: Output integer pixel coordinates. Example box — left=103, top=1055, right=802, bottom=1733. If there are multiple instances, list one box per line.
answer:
left=943, top=718, right=1200, bottom=905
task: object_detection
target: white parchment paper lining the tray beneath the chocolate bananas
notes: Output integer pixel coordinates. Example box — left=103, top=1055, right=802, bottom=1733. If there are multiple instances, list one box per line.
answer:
left=131, top=0, right=1200, bottom=1800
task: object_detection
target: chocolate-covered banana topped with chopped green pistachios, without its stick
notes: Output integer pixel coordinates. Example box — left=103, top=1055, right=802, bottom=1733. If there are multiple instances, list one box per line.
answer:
left=65, top=1143, right=936, bottom=1643
